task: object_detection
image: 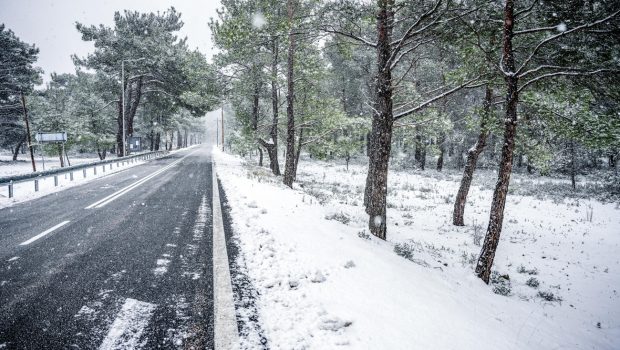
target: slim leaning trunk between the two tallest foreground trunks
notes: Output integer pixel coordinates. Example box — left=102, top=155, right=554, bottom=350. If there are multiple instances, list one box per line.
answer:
left=452, top=85, right=493, bottom=226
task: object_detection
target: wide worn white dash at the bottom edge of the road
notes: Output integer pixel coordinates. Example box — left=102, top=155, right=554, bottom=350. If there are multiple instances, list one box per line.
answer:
left=99, top=298, right=157, bottom=350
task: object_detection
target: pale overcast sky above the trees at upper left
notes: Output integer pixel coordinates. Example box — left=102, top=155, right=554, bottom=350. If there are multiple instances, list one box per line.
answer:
left=0, top=0, right=220, bottom=81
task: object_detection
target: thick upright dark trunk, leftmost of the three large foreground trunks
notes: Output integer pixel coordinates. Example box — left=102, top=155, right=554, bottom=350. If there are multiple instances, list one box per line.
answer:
left=364, top=0, right=394, bottom=239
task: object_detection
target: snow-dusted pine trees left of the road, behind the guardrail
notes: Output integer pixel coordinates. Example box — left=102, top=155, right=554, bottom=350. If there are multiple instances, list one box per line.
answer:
left=0, top=8, right=218, bottom=165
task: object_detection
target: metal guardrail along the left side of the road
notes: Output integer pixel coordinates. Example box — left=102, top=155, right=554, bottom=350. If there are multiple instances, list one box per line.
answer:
left=0, top=151, right=168, bottom=198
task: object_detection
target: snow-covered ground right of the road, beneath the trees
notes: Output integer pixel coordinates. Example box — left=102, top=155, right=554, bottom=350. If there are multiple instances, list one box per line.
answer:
left=214, top=150, right=620, bottom=349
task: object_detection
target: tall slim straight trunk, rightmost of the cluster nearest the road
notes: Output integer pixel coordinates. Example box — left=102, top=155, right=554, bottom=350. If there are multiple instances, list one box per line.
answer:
left=284, top=0, right=296, bottom=187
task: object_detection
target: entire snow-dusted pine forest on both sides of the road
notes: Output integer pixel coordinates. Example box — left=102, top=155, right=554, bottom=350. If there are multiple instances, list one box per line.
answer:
left=0, top=0, right=620, bottom=283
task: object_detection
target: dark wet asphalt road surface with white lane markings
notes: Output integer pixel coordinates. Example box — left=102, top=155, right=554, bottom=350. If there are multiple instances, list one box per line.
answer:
left=0, top=146, right=234, bottom=349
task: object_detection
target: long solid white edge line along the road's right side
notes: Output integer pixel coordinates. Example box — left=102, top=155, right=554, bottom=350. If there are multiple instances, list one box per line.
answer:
left=211, top=164, right=239, bottom=350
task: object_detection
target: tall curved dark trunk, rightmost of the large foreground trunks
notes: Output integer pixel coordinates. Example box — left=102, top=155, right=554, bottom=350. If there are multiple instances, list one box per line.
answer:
left=476, top=0, right=519, bottom=284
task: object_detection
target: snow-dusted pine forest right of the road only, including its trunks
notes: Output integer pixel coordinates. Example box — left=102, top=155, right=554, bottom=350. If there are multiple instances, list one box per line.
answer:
left=211, top=0, right=620, bottom=283
